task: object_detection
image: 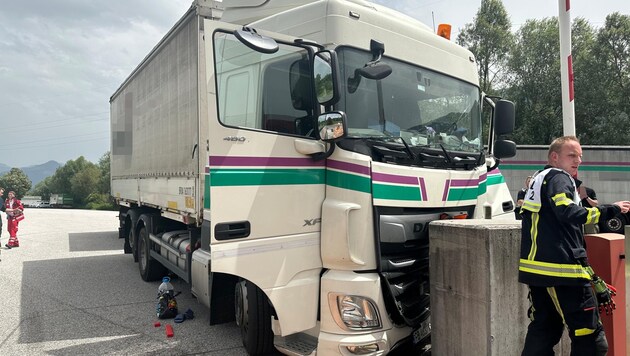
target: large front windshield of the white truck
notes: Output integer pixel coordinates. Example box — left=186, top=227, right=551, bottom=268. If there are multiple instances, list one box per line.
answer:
left=337, top=47, right=483, bottom=153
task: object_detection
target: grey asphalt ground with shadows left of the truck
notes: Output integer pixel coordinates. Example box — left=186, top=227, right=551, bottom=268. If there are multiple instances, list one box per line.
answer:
left=0, top=208, right=252, bottom=356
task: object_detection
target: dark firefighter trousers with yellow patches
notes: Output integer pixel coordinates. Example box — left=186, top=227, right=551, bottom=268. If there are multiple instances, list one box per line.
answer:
left=522, top=283, right=608, bottom=356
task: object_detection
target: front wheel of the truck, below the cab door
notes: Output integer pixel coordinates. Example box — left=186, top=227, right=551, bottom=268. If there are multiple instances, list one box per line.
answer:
left=234, top=281, right=274, bottom=355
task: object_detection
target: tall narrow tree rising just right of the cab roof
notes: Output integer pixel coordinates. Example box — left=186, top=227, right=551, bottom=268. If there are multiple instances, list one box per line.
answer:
left=457, top=0, right=514, bottom=94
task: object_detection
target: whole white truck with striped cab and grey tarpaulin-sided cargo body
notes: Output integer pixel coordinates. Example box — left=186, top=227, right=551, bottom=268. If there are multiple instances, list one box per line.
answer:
left=110, top=0, right=515, bottom=355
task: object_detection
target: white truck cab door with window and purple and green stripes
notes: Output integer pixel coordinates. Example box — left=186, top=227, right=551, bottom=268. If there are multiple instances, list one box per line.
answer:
left=204, top=20, right=325, bottom=334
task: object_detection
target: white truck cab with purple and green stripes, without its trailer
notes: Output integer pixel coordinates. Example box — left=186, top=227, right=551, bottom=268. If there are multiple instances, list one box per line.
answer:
left=205, top=1, right=514, bottom=354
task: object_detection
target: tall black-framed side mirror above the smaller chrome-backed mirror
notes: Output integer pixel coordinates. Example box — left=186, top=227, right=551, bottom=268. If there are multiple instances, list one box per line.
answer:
left=313, top=51, right=340, bottom=106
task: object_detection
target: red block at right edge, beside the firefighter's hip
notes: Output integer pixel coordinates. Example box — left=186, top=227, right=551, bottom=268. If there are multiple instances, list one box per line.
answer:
left=585, top=232, right=628, bottom=356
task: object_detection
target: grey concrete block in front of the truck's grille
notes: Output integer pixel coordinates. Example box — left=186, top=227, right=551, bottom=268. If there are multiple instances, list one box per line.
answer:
left=429, top=220, right=570, bottom=356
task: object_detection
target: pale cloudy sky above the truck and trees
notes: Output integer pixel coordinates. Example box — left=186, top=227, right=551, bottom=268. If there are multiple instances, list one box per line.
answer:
left=0, top=0, right=630, bottom=167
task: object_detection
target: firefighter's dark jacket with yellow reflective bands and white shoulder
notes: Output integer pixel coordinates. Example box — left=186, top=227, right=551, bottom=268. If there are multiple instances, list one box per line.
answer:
left=519, top=166, right=621, bottom=287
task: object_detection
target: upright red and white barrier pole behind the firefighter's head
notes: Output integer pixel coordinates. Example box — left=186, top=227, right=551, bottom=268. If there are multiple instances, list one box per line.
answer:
left=558, top=0, right=575, bottom=135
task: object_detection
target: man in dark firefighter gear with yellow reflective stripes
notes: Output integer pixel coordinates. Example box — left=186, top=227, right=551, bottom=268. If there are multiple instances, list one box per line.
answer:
left=519, top=136, right=630, bottom=356
